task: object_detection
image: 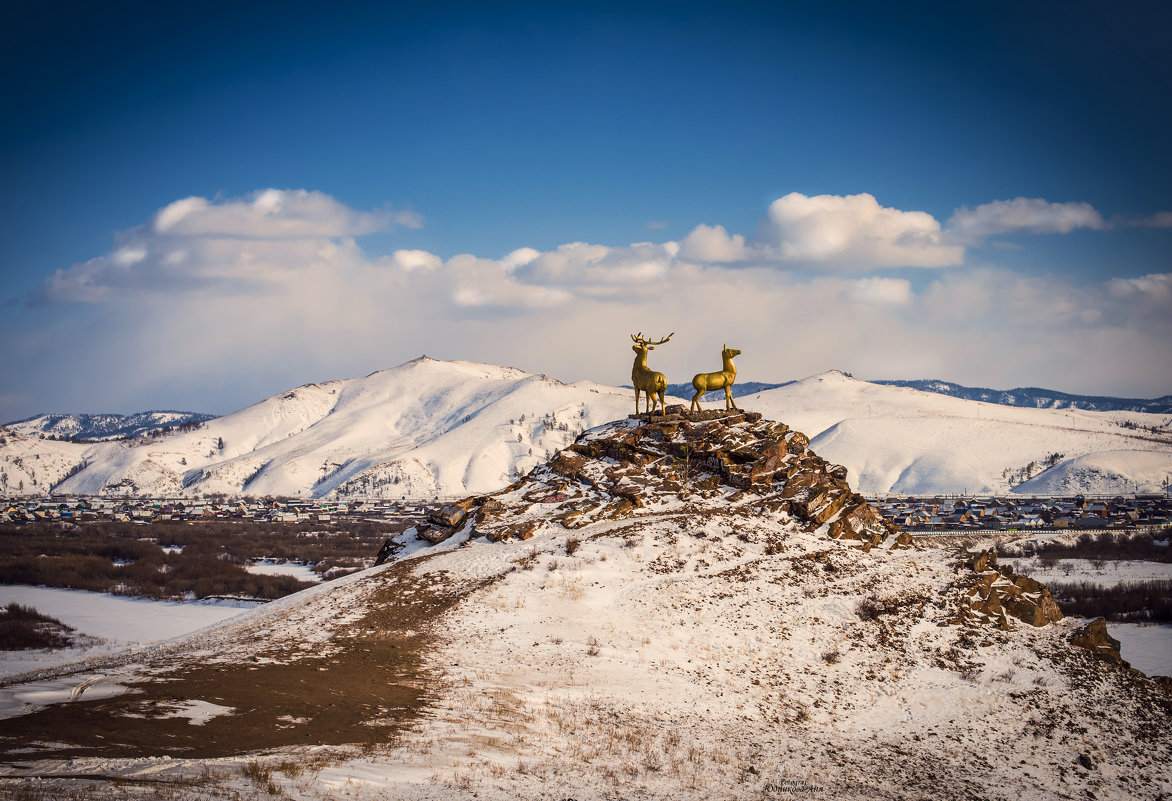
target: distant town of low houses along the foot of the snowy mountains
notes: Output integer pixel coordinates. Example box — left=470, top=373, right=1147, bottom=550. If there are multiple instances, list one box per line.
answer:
left=0, top=494, right=1172, bottom=532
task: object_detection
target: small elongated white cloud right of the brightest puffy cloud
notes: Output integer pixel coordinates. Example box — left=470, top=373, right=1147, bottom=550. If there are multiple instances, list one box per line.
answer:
left=947, top=197, right=1108, bottom=244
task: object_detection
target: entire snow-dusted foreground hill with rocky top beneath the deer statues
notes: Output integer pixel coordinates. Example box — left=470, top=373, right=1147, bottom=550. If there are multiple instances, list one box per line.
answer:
left=0, top=413, right=1172, bottom=801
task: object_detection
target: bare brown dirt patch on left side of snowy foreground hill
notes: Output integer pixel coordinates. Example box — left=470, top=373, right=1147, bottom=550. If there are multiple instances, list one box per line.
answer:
left=0, top=559, right=482, bottom=761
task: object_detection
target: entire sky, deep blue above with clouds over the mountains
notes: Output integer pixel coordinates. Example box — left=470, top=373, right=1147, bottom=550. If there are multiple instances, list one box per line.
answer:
left=0, top=2, right=1172, bottom=412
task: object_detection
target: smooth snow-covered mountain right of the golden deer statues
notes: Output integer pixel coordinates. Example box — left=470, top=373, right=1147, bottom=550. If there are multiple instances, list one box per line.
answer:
left=740, top=371, right=1172, bottom=494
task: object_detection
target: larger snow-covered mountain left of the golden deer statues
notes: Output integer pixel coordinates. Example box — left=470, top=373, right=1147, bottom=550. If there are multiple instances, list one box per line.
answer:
left=50, top=358, right=633, bottom=497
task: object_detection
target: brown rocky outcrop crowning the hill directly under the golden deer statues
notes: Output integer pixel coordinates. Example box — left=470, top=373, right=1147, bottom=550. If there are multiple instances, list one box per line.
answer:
left=421, top=406, right=911, bottom=550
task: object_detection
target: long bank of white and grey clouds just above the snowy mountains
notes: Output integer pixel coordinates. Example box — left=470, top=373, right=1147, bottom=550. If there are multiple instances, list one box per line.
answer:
left=16, top=184, right=1172, bottom=413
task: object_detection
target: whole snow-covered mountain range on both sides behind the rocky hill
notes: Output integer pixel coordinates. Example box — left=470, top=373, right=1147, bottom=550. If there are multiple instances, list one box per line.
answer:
left=0, top=358, right=1172, bottom=498
